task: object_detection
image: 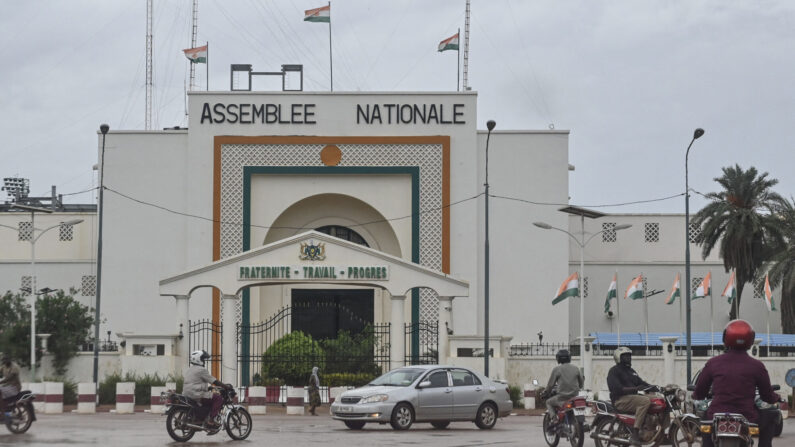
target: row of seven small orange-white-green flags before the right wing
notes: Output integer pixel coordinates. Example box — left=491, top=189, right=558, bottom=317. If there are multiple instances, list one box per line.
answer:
left=552, top=272, right=776, bottom=312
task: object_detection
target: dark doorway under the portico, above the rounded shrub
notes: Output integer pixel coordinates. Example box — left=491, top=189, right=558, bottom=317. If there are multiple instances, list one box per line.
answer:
left=291, top=289, right=374, bottom=340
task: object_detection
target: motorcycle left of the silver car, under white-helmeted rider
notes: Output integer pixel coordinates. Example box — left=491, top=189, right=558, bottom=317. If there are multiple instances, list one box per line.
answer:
left=165, top=386, right=251, bottom=442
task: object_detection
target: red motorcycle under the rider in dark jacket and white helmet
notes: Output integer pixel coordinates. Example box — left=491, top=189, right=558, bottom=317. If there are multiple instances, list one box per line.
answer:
left=590, top=385, right=701, bottom=447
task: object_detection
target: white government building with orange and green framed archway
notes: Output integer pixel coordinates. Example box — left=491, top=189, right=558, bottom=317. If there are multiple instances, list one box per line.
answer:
left=0, top=87, right=780, bottom=383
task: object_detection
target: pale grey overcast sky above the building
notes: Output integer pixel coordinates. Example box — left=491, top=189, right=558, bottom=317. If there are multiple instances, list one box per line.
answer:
left=0, top=0, right=795, bottom=213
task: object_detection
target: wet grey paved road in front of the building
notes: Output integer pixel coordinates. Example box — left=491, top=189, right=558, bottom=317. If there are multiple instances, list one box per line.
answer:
left=0, top=413, right=795, bottom=447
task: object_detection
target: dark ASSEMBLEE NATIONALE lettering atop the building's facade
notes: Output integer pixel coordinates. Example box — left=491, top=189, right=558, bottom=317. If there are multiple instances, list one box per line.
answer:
left=200, top=102, right=466, bottom=124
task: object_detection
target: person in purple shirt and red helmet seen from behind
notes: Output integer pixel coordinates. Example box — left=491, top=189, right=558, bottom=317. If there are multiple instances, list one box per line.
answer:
left=693, top=320, right=779, bottom=447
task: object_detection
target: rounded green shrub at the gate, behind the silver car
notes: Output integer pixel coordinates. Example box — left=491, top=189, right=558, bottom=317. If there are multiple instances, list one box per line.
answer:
left=262, top=331, right=326, bottom=386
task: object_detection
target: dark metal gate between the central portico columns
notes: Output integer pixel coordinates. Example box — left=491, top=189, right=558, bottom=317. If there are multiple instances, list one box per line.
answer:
left=237, top=306, right=391, bottom=386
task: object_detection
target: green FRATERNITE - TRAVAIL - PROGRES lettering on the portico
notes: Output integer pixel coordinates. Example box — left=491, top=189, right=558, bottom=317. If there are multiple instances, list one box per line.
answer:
left=237, top=265, right=389, bottom=281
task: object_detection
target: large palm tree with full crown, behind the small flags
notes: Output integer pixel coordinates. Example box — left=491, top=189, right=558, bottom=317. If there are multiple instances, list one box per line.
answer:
left=687, top=165, right=784, bottom=320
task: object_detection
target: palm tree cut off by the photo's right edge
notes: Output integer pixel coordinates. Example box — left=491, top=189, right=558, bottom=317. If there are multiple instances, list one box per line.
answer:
left=769, top=197, right=795, bottom=334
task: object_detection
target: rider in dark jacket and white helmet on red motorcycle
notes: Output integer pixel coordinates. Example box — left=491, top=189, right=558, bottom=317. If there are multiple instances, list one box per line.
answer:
left=607, top=346, right=654, bottom=446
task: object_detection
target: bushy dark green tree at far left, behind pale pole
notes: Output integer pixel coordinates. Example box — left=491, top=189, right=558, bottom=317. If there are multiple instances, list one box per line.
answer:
left=0, top=290, right=94, bottom=376
